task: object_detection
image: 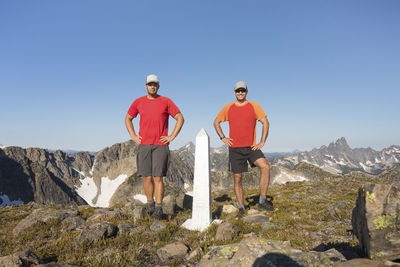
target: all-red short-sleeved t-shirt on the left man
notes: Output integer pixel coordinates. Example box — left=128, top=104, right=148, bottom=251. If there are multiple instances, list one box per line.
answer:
left=128, top=95, right=180, bottom=146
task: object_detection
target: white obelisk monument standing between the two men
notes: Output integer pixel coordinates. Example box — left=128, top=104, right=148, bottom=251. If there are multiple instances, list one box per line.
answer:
left=182, top=128, right=212, bottom=231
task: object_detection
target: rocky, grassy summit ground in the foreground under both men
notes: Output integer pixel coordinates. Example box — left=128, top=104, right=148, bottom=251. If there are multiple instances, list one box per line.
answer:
left=0, top=175, right=400, bottom=266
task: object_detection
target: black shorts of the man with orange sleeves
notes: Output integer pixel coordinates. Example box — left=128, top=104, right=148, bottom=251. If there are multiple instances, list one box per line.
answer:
left=229, top=147, right=265, bottom=173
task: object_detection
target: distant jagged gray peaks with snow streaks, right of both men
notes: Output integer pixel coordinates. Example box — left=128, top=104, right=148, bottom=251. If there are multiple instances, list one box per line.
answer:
left=272, top=137, right=400, bottom=174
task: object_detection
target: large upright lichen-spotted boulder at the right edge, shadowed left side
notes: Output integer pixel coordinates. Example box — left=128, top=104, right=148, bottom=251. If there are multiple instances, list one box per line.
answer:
left=352, top=182, right=400, bottom=260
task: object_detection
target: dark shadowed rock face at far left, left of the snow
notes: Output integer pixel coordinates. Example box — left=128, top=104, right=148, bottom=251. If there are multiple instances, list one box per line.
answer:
left=0, top=147, right=86, bottom=205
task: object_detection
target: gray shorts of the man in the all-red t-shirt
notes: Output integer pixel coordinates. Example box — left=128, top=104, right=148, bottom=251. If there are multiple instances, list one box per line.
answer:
left=136, top=145, right=169, bottom=177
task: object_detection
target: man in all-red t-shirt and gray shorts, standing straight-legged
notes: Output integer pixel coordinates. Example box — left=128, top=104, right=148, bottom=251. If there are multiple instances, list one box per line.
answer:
left=125, top=74, right=184, bottom=219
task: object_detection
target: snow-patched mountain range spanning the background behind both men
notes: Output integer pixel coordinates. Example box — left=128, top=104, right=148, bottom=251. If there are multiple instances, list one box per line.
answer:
left=0, top=138, right=400, bottom=207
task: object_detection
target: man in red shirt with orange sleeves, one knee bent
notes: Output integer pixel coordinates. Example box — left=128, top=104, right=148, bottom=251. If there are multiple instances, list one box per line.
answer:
left=214, top=82, right=274, bottom=218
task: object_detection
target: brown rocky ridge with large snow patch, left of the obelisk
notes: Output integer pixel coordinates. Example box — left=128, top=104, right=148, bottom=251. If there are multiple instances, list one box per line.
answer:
left=0, top=141, right=193, bottom=206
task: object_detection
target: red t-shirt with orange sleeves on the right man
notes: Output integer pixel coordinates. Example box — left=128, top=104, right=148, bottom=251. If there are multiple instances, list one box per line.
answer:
left=217, top=101, right=267, bottom=147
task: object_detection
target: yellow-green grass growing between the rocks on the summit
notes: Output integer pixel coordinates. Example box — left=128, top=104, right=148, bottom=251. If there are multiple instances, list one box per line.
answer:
left=0, top=178, right=388, bottom=266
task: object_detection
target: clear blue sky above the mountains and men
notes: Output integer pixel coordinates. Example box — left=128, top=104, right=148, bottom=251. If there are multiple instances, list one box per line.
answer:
left=0, top=0, right=400, bottom=152
